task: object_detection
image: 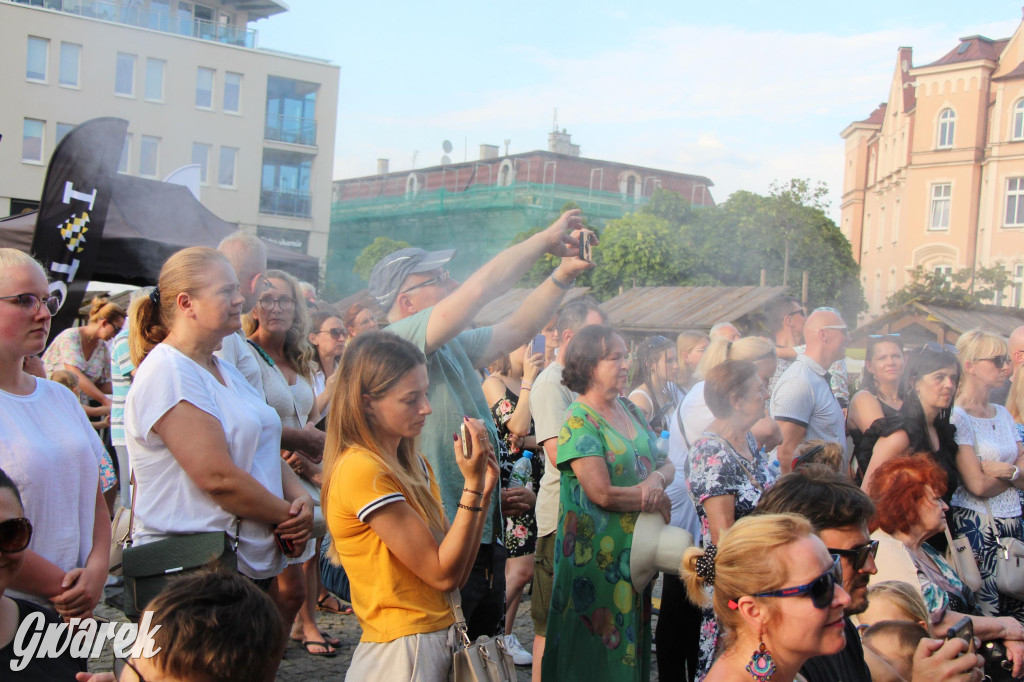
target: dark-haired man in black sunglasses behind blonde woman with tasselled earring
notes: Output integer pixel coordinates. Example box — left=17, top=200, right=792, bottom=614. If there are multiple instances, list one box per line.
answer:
left=754, top=464, right=978, bottom=682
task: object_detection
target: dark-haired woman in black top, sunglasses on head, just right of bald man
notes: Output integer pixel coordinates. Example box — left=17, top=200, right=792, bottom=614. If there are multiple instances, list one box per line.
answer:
left=846, top=334, right=905, bottom=474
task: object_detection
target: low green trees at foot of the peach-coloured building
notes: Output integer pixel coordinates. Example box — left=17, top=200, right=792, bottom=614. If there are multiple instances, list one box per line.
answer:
left=885, top=265, right=1010, bottom=310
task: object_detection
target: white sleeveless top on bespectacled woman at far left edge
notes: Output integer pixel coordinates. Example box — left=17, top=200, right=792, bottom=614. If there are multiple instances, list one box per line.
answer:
left=0, top=379, right=105, bottom=606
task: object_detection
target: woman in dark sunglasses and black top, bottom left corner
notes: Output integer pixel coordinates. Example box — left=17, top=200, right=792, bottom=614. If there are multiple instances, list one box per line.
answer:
left=0, top=469, right=86, bottom=680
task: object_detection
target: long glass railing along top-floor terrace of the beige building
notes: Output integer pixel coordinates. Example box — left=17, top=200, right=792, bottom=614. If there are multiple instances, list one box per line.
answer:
left=12, top=0, right=257, bottom=48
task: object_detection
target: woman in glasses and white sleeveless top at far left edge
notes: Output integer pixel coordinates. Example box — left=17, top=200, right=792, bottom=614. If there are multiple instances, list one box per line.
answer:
left=0, top=249, right=111, bottom=617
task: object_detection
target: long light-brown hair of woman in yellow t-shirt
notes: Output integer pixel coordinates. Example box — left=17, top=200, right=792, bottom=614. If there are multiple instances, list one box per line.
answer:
left=321, top=332, right=444, bottom=561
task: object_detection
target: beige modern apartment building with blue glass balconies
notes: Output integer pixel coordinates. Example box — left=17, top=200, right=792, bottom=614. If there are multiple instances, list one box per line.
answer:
left=0, top=0, right=339, bottom=258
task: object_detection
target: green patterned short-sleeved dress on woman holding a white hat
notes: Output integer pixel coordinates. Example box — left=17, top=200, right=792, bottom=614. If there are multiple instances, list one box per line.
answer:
left=543, top=398, right=663, bottom=682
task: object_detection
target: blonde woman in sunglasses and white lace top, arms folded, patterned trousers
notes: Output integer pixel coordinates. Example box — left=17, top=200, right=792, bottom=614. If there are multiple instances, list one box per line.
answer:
left=950, top=329, right=1024, bottom=623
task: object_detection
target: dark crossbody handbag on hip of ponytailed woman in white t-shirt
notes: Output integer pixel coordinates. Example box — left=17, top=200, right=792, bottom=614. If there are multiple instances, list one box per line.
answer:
left=121, top=473, right=242, bottom=620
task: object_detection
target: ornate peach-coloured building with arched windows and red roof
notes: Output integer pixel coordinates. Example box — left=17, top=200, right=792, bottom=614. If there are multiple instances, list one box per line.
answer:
left=841, top=15, right=1024, bottom=313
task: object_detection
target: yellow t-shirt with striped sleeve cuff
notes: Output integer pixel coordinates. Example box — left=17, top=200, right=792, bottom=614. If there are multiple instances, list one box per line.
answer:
left=327, top=447, right=455, bottom=642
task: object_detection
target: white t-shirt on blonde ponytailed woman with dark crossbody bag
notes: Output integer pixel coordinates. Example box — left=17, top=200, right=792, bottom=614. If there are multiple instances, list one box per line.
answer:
left=125, top=343, right=285, bottom=580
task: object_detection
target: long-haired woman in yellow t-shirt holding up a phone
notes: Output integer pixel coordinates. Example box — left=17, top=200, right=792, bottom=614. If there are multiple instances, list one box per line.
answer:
left=322, top=332, right=499, bottom=682
